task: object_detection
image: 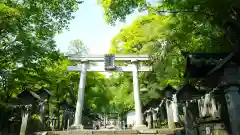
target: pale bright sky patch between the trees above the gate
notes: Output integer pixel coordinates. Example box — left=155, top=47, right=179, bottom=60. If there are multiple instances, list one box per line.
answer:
left=55, top=0, right=143, bottom=54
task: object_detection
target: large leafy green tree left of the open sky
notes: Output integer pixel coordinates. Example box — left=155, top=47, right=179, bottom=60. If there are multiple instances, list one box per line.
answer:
left=0, top=0, right=82, bottom=129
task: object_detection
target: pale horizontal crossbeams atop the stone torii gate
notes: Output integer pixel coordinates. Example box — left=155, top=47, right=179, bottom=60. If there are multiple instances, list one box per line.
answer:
left=65, top=54, right=152, bottom=72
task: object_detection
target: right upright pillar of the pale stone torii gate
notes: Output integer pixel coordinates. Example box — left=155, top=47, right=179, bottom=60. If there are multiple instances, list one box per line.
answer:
left=132, top=60, right=146, bottom=129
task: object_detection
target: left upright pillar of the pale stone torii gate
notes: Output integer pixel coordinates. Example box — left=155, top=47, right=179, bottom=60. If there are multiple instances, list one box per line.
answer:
left=71, top=61, right=88, bottom=129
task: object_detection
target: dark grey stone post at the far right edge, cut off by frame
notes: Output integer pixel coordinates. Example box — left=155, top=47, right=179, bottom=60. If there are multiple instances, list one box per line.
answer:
left=222, top=62, right=240, bottom=135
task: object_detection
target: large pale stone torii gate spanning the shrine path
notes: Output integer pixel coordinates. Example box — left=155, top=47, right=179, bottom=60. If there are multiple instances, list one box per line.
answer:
left=67, top=54, right=152, bottom=129
